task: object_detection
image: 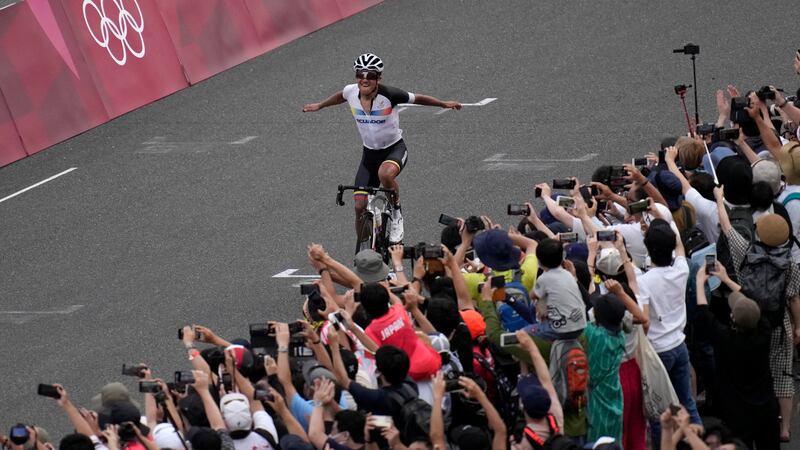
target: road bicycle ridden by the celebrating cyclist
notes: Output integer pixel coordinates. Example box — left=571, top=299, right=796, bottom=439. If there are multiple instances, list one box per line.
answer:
left=336, top=185, right=396, bottom=261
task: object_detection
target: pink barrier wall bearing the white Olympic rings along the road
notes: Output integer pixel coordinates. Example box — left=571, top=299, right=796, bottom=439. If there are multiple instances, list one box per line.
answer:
left=0, top=0, right=382, bottom=166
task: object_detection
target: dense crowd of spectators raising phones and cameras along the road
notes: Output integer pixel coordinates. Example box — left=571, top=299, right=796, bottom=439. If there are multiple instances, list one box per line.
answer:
left=0, top=52, right=800, bottom=450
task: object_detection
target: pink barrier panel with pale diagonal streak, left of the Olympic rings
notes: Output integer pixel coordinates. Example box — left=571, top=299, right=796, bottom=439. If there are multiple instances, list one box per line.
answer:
left=0, top=0, right=108, bottom=155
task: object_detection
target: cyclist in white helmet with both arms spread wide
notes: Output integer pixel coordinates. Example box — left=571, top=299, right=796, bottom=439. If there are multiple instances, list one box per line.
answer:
left=303, top=53, right=461, bottom=243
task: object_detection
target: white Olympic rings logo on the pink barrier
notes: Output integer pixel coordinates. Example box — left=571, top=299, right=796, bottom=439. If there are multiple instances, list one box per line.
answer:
left=83, top=0, right=145, bottom=66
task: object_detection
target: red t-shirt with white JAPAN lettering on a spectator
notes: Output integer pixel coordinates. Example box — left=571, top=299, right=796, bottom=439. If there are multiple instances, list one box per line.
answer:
left=365, top=303, right=442, bottom=381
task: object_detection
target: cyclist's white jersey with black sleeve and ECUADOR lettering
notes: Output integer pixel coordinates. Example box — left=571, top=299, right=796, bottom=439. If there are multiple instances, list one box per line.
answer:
left=342, top=84, right=414, bottom=150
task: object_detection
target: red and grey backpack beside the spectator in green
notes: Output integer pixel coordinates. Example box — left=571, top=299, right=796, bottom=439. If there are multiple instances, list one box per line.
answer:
left=550, top=339, right=589, bottom=411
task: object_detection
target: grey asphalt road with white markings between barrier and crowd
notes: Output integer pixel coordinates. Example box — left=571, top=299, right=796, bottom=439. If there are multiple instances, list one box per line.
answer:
left=0, top=0, right=800, bottom=442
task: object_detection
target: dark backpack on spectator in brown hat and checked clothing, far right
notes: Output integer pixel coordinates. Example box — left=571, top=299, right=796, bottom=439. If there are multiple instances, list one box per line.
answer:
left=739, top=243, right=792, bottom=328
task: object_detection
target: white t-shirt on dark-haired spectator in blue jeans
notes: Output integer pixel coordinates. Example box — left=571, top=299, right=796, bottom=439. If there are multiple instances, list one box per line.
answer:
left=637, top=256, right=689, bottom=353
